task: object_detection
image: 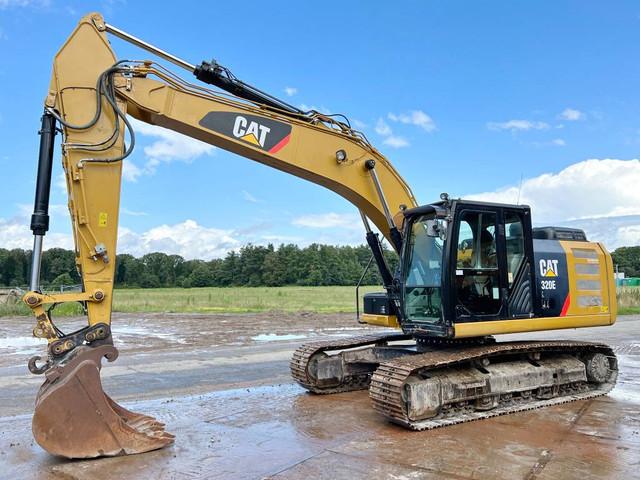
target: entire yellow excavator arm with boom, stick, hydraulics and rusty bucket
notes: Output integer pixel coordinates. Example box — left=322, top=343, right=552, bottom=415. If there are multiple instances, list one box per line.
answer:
left=24, top=14, right=417, bottom=458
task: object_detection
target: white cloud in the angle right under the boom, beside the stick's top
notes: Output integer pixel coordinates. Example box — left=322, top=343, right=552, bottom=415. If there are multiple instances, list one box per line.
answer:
left=129, top=118, right=215, bottom=181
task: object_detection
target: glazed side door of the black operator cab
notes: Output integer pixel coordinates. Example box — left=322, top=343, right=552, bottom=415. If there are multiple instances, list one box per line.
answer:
left=455, top=211, right=502, bottom=318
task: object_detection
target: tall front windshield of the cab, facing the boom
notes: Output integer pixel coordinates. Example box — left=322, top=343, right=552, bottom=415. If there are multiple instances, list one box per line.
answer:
left=403, top=214, right=446, bottom=322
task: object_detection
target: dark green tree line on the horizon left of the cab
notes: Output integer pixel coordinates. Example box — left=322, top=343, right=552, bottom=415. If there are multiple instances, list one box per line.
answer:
left=0, top=244, right=397, bottom=288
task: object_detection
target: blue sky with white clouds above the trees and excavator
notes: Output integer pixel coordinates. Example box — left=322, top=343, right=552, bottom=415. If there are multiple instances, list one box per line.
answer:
left=0, top=0, right=640, bottom=259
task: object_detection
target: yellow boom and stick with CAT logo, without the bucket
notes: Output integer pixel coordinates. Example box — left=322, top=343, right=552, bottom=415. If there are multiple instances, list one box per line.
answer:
left=25, top=14, right=417, bottom=338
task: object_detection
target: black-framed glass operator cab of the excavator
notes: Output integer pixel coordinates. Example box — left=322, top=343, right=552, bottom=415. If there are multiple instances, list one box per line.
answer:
left=394, top=199, right=535, bottom=336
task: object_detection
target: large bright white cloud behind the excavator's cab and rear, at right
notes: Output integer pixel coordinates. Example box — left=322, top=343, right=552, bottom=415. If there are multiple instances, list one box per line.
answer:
left=464, top=159, right=640, bottom=249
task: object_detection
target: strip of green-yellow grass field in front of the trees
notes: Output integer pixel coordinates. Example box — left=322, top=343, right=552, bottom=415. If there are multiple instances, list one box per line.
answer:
left=0, top=286, right=640, bottom=316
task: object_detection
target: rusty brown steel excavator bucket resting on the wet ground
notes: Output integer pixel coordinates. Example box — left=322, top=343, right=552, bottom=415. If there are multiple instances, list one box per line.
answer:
left=32, top=345, right=174, bottom=458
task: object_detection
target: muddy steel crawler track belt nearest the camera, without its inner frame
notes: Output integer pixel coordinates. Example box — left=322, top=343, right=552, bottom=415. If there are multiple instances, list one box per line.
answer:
left=369, top=341, right=617, bottom=430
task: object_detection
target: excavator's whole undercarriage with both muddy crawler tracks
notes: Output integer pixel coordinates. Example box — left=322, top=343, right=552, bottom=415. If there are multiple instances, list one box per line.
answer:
left=291, top=334, right=618, bottom=430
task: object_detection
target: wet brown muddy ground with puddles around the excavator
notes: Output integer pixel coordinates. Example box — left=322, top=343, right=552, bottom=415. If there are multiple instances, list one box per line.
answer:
left=0, top=314, right=640, bottom=480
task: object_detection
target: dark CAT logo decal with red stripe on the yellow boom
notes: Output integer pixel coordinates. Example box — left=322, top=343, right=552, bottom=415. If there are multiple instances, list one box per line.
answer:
left=199, top=112, right=291, bottom=154
